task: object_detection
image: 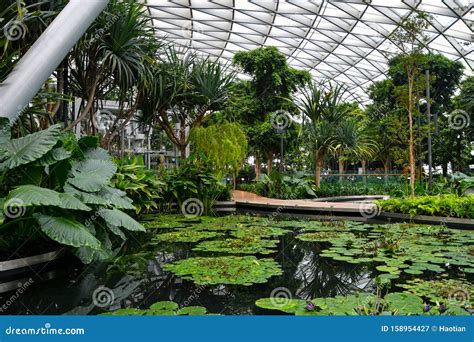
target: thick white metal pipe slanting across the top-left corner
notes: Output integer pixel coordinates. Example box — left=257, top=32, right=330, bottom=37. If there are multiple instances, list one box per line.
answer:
left=0, top=0, right=109, bottom=122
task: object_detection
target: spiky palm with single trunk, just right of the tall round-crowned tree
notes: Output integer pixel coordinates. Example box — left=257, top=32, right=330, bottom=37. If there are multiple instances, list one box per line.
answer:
left=300, top=84, right=348, bottom=188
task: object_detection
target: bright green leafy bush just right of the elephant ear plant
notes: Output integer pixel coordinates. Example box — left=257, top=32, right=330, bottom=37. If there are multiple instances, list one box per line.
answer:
left=112, top=156, right=165, bottom=214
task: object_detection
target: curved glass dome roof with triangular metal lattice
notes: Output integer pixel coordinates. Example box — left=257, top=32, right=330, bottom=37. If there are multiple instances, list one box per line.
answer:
left=146, top=0, right=474, bottom=103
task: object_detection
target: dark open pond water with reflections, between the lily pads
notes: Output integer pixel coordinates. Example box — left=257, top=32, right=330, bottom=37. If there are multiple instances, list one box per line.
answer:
left=2, top=224, right=373, bottom=315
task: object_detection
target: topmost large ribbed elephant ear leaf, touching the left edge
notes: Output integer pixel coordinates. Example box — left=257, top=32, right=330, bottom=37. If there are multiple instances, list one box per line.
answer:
left=0, top=125, right=61, bottom=169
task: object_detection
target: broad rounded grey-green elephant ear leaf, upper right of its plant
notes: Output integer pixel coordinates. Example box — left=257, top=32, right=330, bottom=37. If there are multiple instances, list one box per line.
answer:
left=68, top=159, right=117, bottom=192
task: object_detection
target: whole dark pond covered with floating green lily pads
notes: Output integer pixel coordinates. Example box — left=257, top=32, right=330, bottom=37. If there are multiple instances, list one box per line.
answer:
left=1, top=215, right=474, bottom=315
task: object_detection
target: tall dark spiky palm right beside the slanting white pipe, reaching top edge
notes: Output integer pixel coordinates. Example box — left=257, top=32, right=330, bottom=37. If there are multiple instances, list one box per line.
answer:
left=69, top=0, right=159, bottom=136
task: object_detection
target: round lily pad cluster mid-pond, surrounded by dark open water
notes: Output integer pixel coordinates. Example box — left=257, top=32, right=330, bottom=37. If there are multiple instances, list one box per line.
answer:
left=164, top=256, right=282, bottom=285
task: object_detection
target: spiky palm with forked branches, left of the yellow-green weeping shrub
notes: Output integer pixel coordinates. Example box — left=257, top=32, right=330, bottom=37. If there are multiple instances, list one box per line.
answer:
left=139, top=47, right=234, bottom=158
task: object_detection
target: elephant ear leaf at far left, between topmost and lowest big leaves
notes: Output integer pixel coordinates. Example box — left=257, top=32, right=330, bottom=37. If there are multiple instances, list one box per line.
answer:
left=7, top=185, right=61, bottom=207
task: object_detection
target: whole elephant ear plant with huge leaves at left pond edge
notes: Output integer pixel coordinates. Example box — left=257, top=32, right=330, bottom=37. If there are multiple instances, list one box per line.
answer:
left=0, top=123, right=145, bottom=263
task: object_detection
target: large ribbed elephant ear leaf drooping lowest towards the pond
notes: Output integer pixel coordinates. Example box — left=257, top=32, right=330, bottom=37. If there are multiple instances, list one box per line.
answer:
left=34, top=213, right=101, bottom=249
